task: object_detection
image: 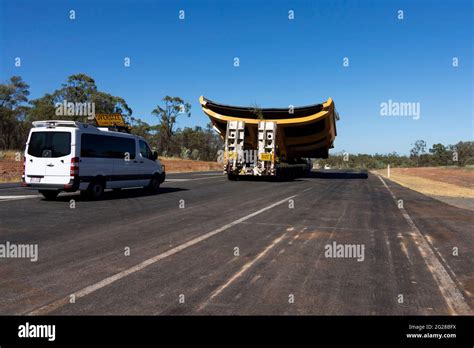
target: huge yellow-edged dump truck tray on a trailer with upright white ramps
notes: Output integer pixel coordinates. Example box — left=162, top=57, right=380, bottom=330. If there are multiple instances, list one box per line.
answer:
left=200, top=96, right=337, bottom=179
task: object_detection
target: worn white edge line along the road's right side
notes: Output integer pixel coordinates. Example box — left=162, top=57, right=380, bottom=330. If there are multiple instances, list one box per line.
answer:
left=377, top=174, right=472, bottom=314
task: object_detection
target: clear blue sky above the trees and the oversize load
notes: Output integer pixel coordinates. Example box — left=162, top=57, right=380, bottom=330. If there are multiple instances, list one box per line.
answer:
left=0, top=0, right=474, bottom=154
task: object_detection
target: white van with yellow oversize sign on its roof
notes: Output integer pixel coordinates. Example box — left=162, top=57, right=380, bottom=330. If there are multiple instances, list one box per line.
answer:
left=22, top=121, right=166, bottom=199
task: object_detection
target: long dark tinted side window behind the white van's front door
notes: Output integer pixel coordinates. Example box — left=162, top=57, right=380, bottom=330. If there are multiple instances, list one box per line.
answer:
left=81, top=134, right=135, bottom=159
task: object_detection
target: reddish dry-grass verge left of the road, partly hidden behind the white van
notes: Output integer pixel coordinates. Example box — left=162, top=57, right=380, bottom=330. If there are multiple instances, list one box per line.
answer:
left=0, top=151, right=222, bottom=183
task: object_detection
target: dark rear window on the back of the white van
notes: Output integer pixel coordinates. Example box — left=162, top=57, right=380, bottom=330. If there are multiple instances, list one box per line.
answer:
left=28, top=132, right=71, bottom=157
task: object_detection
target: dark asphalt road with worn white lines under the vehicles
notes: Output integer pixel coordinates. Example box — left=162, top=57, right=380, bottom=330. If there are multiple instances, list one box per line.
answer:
left=0, top=172, right=474, bottom=315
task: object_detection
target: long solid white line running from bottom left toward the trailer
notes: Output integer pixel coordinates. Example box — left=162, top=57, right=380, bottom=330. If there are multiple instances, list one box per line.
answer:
left=27, top=195, right=297, bottom=315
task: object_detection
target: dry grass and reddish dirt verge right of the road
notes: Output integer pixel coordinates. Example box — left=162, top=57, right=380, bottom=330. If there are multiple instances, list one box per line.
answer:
left=376, top=167, right=474, bottom=198
